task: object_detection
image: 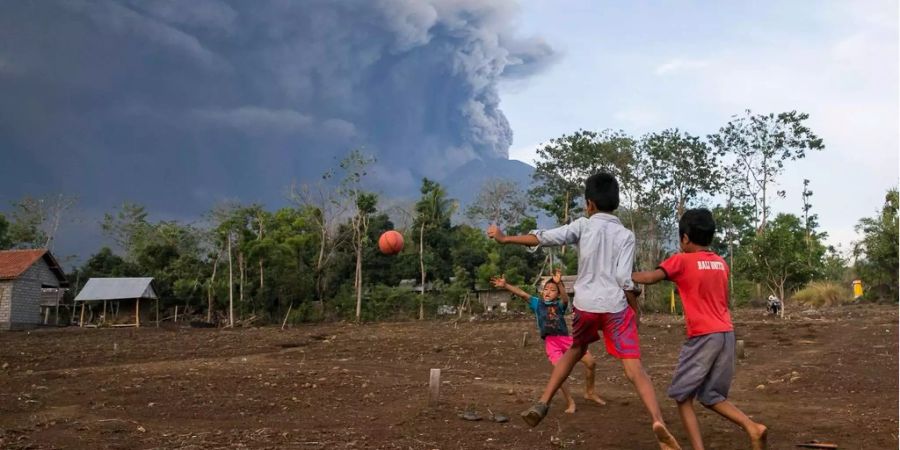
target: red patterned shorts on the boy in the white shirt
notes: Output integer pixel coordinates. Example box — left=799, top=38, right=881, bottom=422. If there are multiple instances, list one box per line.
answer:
left=572, top=306, right=641, bottom=359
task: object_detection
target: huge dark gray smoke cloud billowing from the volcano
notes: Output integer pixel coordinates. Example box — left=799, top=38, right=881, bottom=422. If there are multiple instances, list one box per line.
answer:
left=0, top=0, right=554, bottom=207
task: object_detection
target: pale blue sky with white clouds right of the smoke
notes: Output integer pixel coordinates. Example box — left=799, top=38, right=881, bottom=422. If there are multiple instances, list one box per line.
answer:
left=500, top=1, right=900, bottom=251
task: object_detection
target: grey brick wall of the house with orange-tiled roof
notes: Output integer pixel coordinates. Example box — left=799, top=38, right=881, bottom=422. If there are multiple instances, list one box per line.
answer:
left=0, top=258, right=59, bottom=329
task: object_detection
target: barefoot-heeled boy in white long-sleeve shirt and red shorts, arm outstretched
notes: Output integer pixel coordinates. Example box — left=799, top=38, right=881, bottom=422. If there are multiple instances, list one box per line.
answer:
left=487, top=173, right=681, bottom=450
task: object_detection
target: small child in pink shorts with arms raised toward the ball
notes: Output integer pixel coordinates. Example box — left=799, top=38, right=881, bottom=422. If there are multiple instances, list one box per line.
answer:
left=491, top=269, right=606, bottom=414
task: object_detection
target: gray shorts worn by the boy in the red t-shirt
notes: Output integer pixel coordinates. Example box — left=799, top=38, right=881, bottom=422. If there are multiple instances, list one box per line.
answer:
left=668, top=331, right=734, bottom=406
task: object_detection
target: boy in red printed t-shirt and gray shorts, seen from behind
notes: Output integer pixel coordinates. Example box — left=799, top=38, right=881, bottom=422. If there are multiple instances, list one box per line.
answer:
left=631, top=209, right=767, bottom=450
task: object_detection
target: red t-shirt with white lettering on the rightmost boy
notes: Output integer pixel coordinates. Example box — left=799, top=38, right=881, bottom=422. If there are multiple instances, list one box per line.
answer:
left=659, top=251, right=734, bottom=337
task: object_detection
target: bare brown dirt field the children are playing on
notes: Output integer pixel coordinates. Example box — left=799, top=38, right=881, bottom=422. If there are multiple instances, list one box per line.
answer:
left=0, top=306, right=898, bottom=449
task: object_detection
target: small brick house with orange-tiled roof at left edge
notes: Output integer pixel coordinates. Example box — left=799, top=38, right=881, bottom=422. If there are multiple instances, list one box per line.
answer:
left=0, top=249, right=69, bottom=330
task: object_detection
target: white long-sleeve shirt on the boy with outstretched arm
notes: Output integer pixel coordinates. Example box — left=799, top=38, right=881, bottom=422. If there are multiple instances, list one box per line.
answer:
left=531, top=213, right=634, bottom=313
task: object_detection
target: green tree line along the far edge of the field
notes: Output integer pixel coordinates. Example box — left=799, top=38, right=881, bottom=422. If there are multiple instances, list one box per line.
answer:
left=0, top=111, right=898, bottom=323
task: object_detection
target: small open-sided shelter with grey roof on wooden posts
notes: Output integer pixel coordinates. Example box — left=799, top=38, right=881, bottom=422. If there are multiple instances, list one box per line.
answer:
left=75, top=278, right=159, bottom=327
